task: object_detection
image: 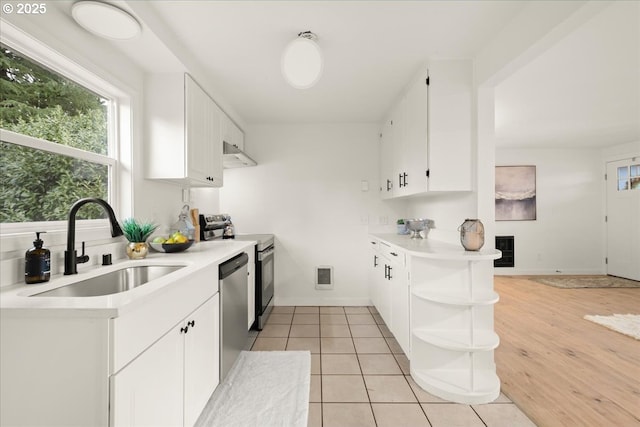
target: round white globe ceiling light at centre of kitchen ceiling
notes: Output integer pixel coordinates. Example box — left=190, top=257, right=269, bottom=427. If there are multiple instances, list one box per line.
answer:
left=280, top=31, right=323, bottom=89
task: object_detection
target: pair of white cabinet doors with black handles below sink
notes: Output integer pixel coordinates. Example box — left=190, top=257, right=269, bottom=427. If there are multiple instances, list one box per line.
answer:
left=110, top=294, right=220, bottom=426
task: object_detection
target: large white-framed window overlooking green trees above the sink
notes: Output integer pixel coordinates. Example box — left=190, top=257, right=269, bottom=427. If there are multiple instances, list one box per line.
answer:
left=0, top=44, right=117, bottom=224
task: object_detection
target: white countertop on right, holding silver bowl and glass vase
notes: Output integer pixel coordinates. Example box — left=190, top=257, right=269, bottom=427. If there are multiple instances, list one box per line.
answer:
left=371, top=233, right=502, bottom=261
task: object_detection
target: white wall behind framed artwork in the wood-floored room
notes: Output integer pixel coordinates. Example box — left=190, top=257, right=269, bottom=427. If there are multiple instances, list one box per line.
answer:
left=495, top=148, right=605, bottom=274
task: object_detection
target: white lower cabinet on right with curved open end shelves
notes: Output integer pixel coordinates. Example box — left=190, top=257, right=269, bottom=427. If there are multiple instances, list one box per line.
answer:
left=370, top=235, right=500, bottom=404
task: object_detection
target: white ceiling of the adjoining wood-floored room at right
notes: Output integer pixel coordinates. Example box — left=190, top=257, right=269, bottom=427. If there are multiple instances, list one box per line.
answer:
left=495, top=1, right=640, bottom=148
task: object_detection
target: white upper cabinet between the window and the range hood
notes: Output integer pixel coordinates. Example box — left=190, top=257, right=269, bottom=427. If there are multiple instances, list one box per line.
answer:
left=145, top=73, right=226, bottom=187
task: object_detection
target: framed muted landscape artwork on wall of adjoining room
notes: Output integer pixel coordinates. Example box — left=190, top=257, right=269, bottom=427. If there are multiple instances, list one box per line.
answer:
left=496, top=166, right=536, bottom=221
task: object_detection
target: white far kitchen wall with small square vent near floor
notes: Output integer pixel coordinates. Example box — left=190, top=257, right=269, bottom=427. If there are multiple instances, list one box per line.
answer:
left=220, top=124, right=405, bottom=305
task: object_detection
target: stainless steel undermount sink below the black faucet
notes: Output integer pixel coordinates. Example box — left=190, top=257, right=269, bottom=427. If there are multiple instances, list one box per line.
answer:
left=31, top=265, right=184, bottom=297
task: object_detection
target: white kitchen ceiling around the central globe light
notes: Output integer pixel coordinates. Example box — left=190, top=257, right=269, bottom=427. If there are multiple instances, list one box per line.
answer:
left=117, top=0, right=525, bottom=123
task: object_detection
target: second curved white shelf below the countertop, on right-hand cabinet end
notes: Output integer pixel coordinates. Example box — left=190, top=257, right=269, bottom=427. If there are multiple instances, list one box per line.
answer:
left=413, top=328, right=500, bottom=351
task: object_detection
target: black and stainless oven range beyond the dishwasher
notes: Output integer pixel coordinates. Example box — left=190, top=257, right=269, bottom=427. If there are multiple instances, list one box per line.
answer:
left=235, top=234, right=275, bottom=331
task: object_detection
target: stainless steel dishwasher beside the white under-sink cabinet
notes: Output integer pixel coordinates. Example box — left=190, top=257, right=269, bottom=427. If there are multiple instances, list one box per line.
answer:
left=218, top=252, right=249, bottom=381
